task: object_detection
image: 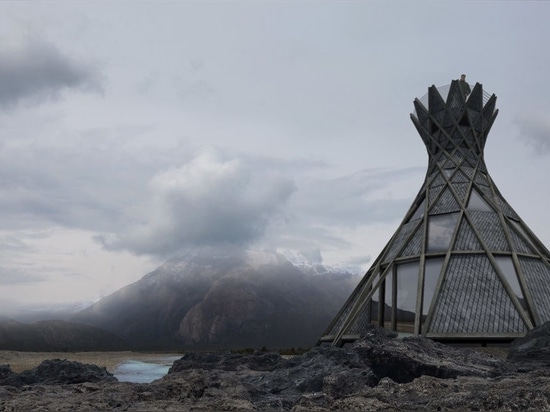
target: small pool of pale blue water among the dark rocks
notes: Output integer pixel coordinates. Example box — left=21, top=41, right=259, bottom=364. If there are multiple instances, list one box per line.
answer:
left=113, top=356, right=181, bottom=383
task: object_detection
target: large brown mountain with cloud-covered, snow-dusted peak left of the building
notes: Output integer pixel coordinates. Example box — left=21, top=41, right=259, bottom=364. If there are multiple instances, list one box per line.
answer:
left=73, top=250, right=358, bottom=349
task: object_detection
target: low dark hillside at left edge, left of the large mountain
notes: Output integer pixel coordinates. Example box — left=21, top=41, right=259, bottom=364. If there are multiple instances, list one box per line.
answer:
left=0, top=319, right=127, bottom=352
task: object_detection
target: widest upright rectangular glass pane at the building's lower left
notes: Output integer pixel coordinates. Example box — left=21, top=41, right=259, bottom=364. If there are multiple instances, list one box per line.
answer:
left=396, top=262, right=418, bottom=333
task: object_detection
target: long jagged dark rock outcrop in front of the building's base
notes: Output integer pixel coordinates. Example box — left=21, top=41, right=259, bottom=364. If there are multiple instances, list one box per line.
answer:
left=169, top=327, right=507, bottom=409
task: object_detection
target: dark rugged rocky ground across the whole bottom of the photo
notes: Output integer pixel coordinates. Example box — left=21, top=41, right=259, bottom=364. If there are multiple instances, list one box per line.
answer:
left=0, top=325, right=550, bottom=411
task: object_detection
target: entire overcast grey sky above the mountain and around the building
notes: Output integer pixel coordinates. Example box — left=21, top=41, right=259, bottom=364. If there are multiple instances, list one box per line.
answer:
left=0, top=1, right=550, bottom=305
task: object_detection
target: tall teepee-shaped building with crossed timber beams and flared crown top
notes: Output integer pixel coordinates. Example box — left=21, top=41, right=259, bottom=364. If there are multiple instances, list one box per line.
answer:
left=319, top=79, right=550, bottom=346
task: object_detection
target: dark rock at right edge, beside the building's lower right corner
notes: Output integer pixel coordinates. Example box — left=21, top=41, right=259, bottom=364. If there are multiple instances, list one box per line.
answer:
left=508, top=322, right=550, bottom=364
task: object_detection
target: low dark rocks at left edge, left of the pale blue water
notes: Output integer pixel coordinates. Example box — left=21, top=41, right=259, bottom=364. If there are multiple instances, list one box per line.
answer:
left=0, top=359, right=117, bottom=387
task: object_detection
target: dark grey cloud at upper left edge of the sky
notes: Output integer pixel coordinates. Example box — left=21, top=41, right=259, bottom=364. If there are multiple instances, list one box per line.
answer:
left=0, top=37, right=101, bottom=108
